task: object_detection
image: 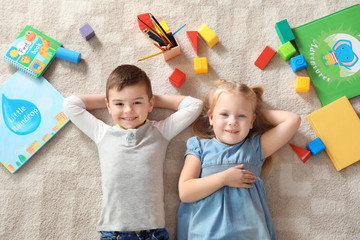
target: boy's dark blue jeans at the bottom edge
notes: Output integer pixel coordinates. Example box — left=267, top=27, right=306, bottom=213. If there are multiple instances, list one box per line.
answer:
left=100, top=228, right=169, bottom=240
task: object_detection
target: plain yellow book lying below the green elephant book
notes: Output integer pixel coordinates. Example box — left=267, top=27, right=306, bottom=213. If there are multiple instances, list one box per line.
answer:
left=306, top=96, right=360, bottom=171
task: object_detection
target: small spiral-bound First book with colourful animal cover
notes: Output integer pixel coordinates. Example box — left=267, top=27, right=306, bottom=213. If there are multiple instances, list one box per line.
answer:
left=3, top=25, right=62, bottom=77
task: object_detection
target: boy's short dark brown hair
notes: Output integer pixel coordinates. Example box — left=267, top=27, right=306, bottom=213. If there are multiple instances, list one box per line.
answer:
left=106, top=65, right=153, bottom=101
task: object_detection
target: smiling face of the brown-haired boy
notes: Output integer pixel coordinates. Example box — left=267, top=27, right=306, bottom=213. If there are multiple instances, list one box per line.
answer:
left=105, top=84, right=154, bottom=129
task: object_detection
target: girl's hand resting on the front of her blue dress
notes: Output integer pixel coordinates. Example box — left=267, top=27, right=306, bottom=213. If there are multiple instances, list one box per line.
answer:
left=224, top=164, right=256, bottom=188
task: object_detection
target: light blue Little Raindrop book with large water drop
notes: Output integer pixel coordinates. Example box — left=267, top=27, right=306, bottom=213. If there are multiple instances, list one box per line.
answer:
left=0, top=71, right=69, bottom=173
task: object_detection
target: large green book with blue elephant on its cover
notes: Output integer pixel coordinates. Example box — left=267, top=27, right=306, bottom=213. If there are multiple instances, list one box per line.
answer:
left=292, top=4, right=360, bottom=106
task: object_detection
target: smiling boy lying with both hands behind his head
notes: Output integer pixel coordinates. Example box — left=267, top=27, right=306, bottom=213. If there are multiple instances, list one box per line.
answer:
left=64, top=65, right=202, bottom=239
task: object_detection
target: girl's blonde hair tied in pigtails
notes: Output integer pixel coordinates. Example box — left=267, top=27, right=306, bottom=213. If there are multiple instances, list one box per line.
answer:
left=192, top=80, right=274, bottom=169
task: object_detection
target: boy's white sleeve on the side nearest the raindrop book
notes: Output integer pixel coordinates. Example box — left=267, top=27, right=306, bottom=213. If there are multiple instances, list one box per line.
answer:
left=63, top=96, right=108, bottom=143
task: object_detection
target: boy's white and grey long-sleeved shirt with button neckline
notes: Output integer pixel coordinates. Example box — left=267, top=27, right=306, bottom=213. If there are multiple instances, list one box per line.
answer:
left=64, top=96, right=202, bottom=231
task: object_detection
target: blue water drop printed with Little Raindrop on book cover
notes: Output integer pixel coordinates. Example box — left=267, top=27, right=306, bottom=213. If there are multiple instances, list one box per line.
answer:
left=2, top=94, right=41, bottom=135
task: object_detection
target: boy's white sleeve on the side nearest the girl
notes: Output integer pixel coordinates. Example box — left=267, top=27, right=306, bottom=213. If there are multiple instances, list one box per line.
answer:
left=155, top=96, right=203, bottom=141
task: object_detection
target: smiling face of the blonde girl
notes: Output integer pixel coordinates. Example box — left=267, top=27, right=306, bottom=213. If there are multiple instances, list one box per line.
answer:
left=209, top=92, right=255, bottom=145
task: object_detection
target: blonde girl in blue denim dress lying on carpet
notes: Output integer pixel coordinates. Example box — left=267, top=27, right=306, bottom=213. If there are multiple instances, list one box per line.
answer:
left=177, top=81, right=300, bottom=240
